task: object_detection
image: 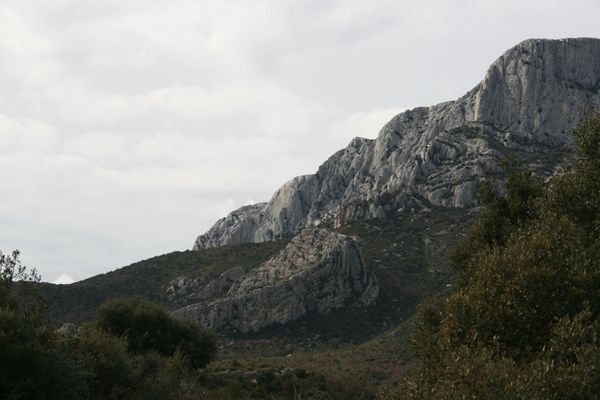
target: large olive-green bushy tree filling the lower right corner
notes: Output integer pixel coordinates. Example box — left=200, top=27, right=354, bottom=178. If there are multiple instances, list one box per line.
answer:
left=404, top=116, right=600, bottom=399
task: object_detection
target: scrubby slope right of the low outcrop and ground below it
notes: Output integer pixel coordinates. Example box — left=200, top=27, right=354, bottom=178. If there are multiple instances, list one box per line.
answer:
left=207, top=208, right=474, bottom=399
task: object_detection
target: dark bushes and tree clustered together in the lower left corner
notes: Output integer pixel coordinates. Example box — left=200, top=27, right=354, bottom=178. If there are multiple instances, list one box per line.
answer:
left=0, top=251, right=216, bottom=400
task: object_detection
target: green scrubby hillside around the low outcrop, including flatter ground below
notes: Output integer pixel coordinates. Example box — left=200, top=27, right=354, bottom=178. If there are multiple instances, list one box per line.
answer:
left=44, top=207, right=477, bottom=398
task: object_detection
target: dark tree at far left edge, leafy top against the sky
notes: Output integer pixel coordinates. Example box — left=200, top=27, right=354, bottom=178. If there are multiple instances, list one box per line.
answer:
left=0, top=251, right=85, bottom=400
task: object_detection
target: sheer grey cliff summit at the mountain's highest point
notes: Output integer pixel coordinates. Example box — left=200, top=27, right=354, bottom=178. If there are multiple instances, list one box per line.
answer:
left=470, top=38, right=600, bottom=145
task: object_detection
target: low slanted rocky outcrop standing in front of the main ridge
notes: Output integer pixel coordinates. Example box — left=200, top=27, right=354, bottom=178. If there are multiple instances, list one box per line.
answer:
left=173, top=228, right=379, bottom=333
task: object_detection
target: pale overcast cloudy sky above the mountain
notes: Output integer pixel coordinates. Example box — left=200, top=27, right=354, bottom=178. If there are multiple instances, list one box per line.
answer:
left=0, top=0, right=600, bottom=283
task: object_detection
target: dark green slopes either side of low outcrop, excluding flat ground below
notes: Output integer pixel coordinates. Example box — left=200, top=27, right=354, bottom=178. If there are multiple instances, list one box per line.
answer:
left=43, top=208, right=474, bottom=341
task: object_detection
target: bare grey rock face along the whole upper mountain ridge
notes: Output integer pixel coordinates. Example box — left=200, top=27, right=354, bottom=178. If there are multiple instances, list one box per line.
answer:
left=194, top=39, right=600, bottom=249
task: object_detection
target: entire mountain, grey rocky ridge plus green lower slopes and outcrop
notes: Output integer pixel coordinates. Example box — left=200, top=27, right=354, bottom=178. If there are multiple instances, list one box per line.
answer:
left=44, top=39, right=600, bottom=340
